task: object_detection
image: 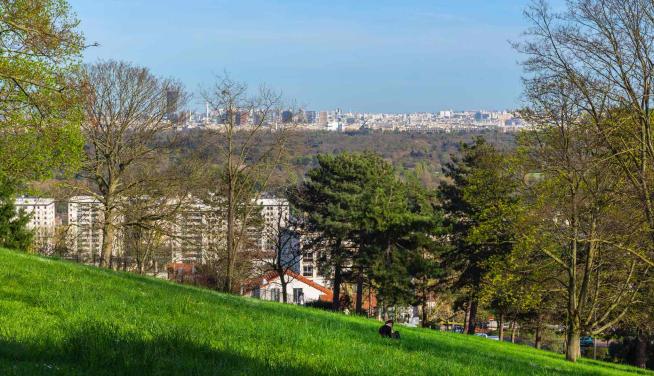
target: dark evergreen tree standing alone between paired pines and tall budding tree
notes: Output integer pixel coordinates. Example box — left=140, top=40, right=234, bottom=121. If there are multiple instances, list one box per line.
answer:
left=440, top=138, right=516, bottom=334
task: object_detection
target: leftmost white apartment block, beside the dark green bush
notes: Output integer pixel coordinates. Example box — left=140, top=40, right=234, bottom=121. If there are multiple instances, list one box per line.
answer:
left=16, top=197, right=56, bottom=250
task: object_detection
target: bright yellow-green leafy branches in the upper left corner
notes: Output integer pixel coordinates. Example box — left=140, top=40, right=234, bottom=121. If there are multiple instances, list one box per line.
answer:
left=0, top=0, right=83, bottom=179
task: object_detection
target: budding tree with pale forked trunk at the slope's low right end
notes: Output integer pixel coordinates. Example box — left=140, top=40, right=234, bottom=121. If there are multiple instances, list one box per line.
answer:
left=522, top=82, right=649, bottom=361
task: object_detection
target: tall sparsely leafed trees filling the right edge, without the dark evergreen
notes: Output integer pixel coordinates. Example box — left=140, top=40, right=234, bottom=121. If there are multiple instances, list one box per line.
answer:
left=516, top=0, right=654, bottom=366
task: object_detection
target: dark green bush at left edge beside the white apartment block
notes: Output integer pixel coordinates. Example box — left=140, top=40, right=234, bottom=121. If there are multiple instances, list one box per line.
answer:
left=0, top=179, right=33, bottom=250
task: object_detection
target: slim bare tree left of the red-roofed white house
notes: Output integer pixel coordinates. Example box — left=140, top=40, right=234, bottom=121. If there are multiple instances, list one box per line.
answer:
left=203, top=78, right=287, bottom=292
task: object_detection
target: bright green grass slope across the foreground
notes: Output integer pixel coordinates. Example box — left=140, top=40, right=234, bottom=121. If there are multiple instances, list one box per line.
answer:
left=0, top=250, right=654, bottom=376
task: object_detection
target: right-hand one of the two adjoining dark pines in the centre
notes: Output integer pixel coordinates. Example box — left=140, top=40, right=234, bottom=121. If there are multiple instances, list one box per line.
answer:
left=360, top=174, right=442, bottom=322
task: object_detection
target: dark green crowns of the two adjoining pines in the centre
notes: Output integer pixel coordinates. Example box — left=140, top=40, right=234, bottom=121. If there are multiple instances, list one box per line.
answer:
left=291, top=152, right=448, bottom=305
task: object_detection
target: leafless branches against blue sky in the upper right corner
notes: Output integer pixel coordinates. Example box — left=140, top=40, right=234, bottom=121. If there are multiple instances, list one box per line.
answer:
left=515, top=0, right=654, bottom=266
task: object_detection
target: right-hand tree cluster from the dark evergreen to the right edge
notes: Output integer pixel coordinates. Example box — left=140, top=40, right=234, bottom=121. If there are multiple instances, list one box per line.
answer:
left=430, top=0, right=654, bottom=367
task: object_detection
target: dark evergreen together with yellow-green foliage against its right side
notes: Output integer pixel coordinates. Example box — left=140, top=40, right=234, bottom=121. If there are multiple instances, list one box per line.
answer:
left=440, top=138, right=525, bottom=333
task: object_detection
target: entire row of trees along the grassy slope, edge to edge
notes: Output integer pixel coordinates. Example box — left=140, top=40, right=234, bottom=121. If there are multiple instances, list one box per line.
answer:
left=0, top=0, right=654, bottom=366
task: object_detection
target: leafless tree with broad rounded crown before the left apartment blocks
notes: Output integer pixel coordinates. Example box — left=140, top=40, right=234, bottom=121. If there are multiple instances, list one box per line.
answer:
left=82, top=61, right=186, bottom=267
